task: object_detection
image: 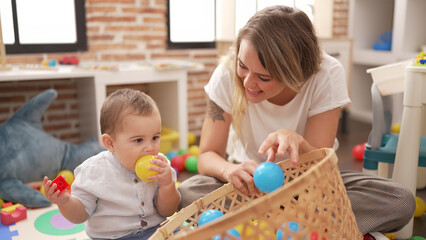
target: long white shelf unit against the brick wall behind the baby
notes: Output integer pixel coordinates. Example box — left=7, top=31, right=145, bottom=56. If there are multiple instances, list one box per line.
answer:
left=0, top=60, right=204, bottom=152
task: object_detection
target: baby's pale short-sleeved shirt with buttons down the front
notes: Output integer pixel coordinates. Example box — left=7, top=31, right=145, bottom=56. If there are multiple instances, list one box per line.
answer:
left=71, top=151, right=176, bottom=238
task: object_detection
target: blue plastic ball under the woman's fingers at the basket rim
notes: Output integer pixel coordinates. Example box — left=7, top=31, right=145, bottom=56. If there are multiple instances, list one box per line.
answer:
left=253, top=162, right=285, bottom=193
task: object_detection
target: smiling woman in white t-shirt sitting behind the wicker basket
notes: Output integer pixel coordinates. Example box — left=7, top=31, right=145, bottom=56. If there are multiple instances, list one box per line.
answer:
left=179, top=6, right=415, bottom=234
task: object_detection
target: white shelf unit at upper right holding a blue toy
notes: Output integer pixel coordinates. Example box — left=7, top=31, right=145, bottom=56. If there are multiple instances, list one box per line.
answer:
left=349, top=0, right=426, bottom=123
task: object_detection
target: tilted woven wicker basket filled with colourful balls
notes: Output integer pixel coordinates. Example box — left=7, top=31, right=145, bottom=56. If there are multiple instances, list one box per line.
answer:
left=150, top=148, right=363, bottom=240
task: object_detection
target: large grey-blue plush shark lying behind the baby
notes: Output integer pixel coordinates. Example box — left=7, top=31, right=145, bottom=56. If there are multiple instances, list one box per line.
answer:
left=0, top=89, right=104, bottom=207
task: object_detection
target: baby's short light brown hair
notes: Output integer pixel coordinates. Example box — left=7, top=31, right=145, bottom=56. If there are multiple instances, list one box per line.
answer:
left=100, top=88, right=159, bottom=135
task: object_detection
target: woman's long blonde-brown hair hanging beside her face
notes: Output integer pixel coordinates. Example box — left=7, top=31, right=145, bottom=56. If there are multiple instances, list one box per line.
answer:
left=225, top=6, right=321, bottom=138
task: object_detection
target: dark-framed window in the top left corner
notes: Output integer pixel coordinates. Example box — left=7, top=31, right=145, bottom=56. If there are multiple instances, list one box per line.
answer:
left=0, top=0, right=87, bottom=54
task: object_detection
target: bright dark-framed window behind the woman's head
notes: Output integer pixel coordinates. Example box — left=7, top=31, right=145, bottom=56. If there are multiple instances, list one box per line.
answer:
left=167, top=0, right=314, bottom=49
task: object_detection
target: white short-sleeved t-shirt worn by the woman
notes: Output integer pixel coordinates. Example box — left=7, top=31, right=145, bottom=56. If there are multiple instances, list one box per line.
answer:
left=204, top=52, right=350, bottom=162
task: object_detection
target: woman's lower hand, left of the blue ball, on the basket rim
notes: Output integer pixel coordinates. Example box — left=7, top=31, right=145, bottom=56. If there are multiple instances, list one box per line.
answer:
left=224, top=160, right=258, bottom=196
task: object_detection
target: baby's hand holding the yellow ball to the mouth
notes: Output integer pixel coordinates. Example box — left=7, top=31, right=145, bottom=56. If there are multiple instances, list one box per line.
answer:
left=147, top=155, right=174, bottom=187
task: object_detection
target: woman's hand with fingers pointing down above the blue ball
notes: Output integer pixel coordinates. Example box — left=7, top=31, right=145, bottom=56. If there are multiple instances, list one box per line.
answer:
left=258, top=129, right=305, bottom=168
